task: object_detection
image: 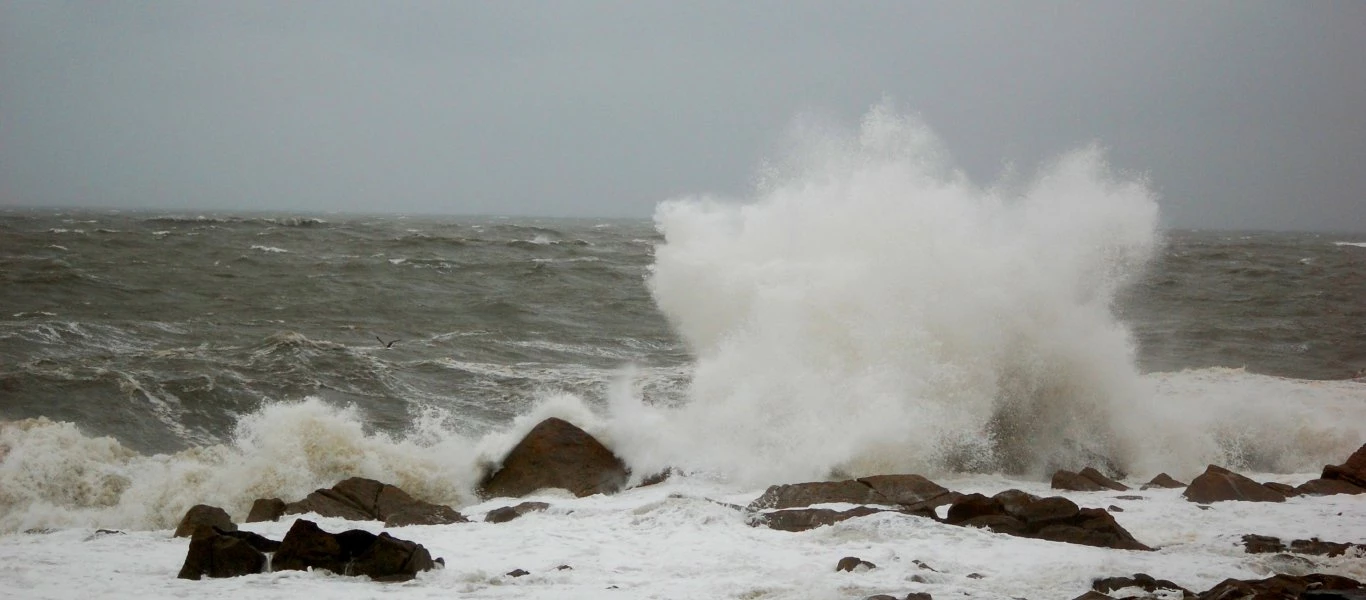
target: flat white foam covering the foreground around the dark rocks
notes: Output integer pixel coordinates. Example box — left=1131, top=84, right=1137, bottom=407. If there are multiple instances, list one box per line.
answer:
left=0, top=474, right=1366, bottom=599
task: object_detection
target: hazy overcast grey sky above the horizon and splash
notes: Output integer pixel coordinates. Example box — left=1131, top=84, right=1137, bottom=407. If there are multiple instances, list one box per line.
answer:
left=0, top=0, right=1366, bottom=231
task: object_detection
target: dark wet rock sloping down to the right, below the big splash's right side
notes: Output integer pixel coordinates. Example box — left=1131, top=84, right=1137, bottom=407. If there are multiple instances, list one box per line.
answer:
left=944, top=489, right=1152, bottom=551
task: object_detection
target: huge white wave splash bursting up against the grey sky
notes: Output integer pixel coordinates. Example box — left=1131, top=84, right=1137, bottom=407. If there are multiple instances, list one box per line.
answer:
left=649, top=103, right=1160, bottom=482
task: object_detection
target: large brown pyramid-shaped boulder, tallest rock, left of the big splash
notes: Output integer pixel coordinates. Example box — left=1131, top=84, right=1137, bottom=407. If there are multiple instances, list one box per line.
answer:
left=479, top=418, right=630, bottom=497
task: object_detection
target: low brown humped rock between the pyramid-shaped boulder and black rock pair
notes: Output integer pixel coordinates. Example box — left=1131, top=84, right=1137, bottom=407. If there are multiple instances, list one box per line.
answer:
left=284, top=477, right=469, bottom=528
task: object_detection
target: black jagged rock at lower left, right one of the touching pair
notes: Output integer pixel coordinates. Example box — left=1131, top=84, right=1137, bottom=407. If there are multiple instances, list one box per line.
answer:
left=270, top=519, right=437, bottom=581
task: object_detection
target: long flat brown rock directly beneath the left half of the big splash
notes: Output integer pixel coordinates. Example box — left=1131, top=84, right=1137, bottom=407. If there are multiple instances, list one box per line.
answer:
left=749, top=474, right=962, bottom=511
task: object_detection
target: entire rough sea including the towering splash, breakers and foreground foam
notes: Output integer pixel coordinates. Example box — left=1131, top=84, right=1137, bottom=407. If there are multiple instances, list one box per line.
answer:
left=0, top=112, right=1366, bottom=599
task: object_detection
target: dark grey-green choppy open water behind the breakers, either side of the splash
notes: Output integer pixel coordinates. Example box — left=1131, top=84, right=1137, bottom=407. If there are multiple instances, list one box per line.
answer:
left=0, top=210, right=1366, bottom=452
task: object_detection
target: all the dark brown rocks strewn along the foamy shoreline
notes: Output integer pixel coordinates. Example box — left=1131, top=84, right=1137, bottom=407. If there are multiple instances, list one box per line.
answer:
left=176, top=418, right=1366, bottom=600
